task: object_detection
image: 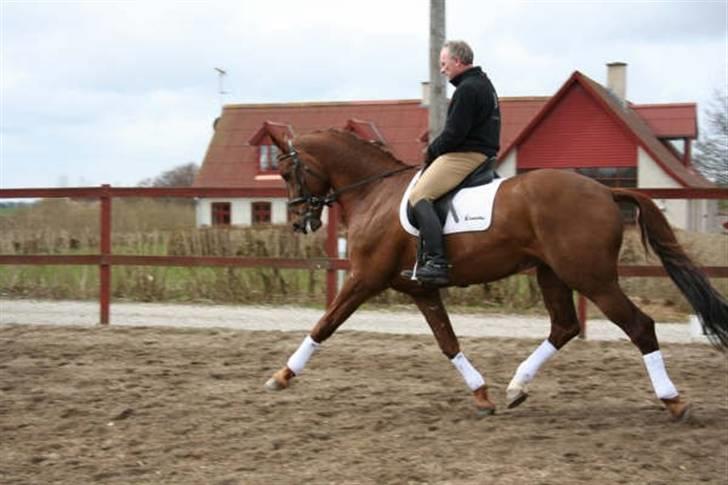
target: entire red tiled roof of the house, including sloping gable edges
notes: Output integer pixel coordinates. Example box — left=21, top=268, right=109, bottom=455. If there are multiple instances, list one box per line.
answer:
left=195, top=80, right=712, bottom=188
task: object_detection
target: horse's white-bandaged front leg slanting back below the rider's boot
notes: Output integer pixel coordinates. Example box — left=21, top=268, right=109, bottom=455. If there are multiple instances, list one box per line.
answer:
left=412, top=290, right=495, bottom=416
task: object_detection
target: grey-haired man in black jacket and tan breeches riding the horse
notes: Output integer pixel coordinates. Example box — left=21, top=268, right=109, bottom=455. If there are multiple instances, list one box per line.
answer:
left=402, top=41, right=501, bottom=286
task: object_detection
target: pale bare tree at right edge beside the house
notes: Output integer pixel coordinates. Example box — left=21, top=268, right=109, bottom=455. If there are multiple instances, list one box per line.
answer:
left=693, top=91, right=728, bottom=187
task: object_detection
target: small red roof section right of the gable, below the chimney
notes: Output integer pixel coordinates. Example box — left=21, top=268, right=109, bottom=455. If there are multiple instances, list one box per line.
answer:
left=630, top=103, right=698, bottom=140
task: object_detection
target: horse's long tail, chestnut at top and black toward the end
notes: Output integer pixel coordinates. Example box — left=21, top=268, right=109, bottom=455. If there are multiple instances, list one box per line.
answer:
left=612, top=189, right=728, bottom=350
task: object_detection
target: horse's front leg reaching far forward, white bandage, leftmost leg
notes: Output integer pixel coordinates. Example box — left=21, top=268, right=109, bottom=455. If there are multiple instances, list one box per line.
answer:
left=265, top=272, right=377, bottom=391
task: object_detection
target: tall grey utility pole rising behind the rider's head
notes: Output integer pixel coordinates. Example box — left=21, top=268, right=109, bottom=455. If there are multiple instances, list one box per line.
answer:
left=428, top=0, right=447, bottom=141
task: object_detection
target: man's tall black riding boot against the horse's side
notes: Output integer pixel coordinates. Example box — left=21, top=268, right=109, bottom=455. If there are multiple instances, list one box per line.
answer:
left=402, top=199, right=450, bottom=286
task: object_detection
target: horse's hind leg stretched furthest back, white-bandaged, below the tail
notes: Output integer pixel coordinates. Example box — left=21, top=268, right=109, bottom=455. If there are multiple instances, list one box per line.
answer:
left=585, top=282, right=690, bottom=420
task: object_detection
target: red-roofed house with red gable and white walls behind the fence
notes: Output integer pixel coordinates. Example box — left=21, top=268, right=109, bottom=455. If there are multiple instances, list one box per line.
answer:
left=195, top=63, right=716, bottom=230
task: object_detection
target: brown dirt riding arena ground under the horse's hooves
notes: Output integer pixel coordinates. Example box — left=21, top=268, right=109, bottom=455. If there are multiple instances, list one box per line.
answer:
left=0, top=325, right=728, bottom=485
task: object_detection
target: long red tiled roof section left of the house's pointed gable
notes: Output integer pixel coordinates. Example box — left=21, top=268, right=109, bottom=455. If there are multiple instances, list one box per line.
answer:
left=195, top=97, right=548, bottom=187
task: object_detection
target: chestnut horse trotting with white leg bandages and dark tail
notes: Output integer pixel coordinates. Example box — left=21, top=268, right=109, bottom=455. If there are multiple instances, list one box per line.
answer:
left=266, top=130, right=728, bottom=419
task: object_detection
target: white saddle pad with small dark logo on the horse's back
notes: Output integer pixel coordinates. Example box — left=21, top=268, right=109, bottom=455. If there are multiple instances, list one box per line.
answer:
left=399, top=170, right=506, bottom=236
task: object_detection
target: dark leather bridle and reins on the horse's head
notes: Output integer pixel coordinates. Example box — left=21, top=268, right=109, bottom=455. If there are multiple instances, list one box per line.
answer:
left=278, top=140, right=417, bottom=234
